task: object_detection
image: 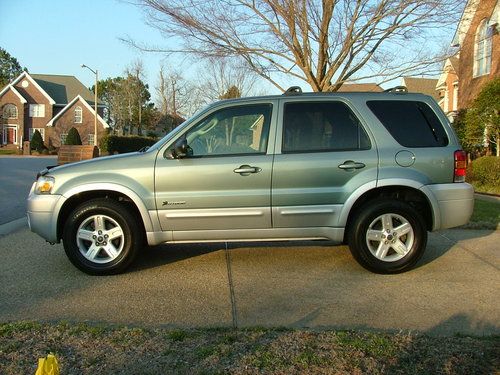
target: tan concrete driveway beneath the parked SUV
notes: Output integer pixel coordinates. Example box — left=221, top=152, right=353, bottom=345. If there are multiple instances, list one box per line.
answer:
left=0, top=225, right=500, bottom=335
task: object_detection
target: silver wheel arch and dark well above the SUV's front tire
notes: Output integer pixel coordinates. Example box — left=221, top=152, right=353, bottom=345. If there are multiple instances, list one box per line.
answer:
left=57, top=184, right=153, bottom=240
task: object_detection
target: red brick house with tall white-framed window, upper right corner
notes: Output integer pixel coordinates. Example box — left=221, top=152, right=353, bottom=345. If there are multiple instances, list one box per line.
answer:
left=453, top=0, right=500, bottom=109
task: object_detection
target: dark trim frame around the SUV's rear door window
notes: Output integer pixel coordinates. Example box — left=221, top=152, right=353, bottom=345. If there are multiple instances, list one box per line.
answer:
left=279, top=98, right=373, bottom=155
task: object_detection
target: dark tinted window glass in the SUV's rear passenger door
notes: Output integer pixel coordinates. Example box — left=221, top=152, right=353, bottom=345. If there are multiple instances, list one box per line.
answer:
left=282, top=102, right=370, bottom=152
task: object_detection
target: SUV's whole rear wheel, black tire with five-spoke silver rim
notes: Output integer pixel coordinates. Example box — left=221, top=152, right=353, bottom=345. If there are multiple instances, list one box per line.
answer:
left=348, top=199, right=427, bottom=274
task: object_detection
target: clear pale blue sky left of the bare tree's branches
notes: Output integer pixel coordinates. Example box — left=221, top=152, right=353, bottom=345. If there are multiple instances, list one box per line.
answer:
left=0, top=0, right=195, bottom=96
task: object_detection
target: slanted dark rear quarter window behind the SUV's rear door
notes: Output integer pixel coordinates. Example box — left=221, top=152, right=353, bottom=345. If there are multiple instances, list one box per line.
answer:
left=366, top=100, right=448, bottom=147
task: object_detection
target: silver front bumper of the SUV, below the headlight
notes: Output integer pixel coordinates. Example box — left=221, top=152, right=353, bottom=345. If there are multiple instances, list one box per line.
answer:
left=27, top=184, right=64, bottom=243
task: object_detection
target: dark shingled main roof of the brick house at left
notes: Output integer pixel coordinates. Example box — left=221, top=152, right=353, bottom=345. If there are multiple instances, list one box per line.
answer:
left=30, top=74, right=102, bottom=105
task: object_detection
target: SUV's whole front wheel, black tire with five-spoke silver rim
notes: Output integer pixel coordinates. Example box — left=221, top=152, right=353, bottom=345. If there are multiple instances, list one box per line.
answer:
left=62, top=198, right=144, bottom=275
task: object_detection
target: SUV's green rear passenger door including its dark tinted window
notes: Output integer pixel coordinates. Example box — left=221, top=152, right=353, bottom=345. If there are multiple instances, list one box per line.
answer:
left=272, top=98, right=378, bottom=228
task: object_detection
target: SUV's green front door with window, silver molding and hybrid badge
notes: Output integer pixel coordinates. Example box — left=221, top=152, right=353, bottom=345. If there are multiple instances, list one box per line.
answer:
left=155, top=102, right=273, bottom=234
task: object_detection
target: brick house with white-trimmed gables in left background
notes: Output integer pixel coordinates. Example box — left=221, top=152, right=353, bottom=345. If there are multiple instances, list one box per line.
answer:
left=0, top=72, right=109, bottom=147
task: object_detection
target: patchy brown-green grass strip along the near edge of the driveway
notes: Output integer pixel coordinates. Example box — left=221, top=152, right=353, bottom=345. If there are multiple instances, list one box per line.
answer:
left=0, top=322, right=500, bottom=375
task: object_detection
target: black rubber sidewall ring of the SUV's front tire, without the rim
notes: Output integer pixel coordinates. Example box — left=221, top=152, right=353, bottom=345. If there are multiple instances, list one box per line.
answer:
left=63, top=199, right=137, bottom=275
